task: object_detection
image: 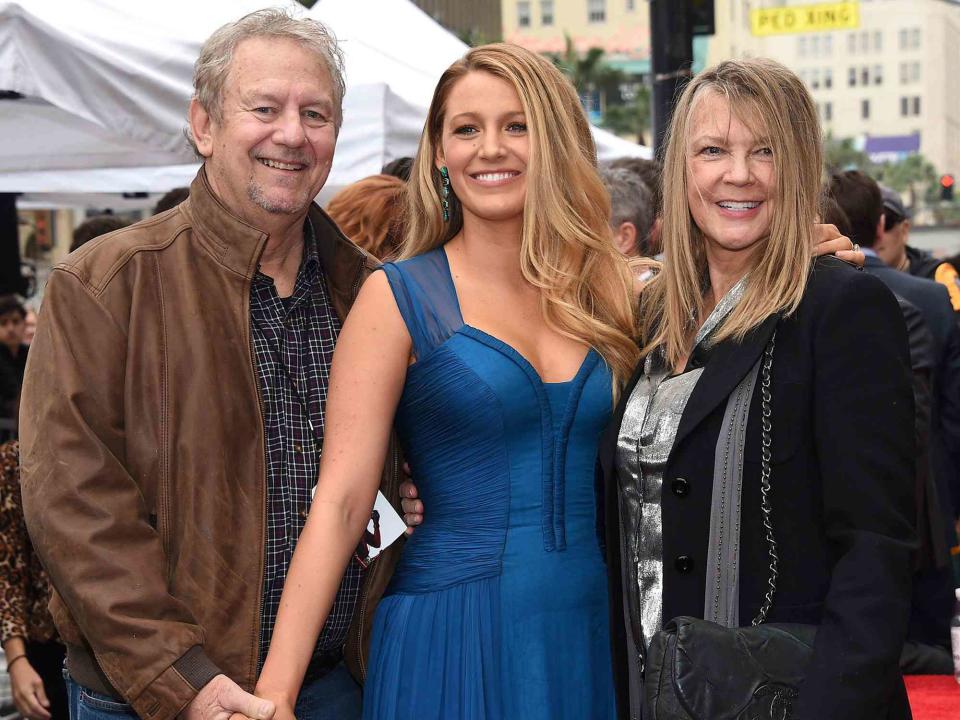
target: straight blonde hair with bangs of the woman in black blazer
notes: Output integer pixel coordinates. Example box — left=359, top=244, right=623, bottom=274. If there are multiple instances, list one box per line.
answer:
left=640, top=58, right=823, bottom=367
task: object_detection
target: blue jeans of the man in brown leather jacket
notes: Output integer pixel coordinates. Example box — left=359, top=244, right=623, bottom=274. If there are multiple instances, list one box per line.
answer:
left=64, top=663, right=362, bottom=720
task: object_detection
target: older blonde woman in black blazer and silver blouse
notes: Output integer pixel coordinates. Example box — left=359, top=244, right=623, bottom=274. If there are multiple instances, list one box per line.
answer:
left=601, top=60, right=913, bottom=720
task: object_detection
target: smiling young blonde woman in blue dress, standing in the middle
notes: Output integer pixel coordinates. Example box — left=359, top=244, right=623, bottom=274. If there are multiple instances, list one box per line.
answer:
left=257, top=45, right=638, bottom=720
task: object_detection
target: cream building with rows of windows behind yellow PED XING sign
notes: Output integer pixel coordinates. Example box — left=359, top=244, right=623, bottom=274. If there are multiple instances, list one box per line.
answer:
left=707, top=0, right=960, bottom=174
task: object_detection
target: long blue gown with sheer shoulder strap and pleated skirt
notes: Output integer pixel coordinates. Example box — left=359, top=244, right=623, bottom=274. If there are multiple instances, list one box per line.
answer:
left=363, top=248, right=615, bottom=720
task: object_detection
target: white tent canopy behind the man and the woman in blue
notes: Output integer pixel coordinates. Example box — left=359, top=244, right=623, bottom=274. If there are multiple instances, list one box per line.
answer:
left=0, top=0, right=650, bottom=204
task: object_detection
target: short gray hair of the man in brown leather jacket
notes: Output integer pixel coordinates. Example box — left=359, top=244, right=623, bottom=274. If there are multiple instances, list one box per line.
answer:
left=187, top=8, right=347, bottom=150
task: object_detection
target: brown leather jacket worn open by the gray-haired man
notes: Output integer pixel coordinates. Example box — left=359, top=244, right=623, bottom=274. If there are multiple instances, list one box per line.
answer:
left=21, top=169, right=399, bottom=720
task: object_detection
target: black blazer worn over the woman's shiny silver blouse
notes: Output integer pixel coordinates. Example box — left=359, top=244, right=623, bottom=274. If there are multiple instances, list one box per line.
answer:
left=600, top=257, right=916, bottom=720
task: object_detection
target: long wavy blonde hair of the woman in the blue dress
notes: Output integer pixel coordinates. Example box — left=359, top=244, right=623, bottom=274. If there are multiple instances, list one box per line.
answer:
left=401, top=43, right=639, bottom=390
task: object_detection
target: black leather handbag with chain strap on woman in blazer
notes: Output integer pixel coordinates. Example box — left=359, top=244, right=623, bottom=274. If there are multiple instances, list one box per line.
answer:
left=643, top=334, right=817, bottom=720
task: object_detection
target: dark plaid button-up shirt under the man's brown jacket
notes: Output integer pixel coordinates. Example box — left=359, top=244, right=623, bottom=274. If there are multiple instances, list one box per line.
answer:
left=250, top=225, right=362, bottom=667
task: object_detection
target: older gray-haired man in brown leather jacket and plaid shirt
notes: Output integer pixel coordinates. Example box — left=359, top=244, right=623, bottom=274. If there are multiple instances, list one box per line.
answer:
left=21, top=10, right=396, bottom=720
